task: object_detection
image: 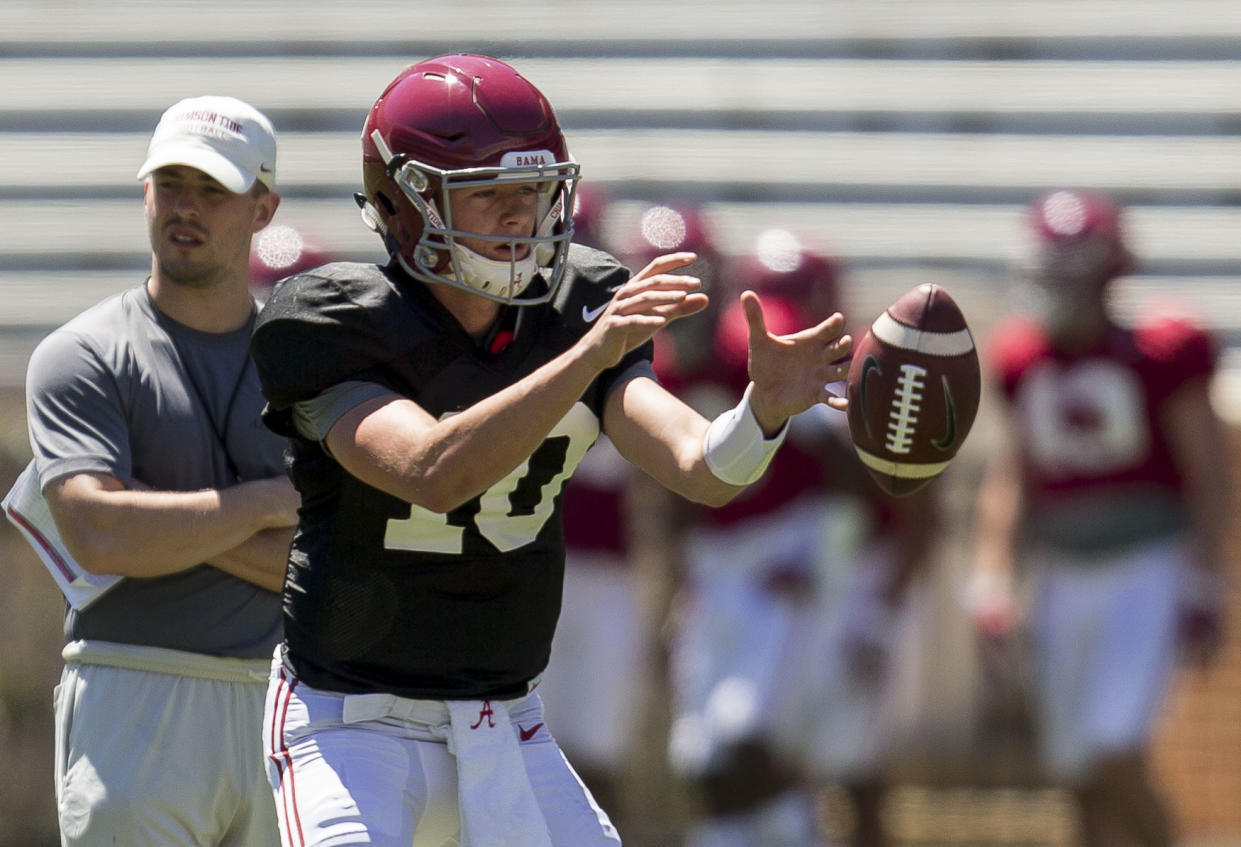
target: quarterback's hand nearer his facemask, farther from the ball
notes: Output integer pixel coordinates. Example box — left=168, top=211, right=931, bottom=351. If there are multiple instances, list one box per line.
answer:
left=583, top=253, right=707, bottom=370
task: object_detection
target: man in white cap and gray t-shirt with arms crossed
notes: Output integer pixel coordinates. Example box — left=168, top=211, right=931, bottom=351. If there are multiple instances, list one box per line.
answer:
left=13, top=97, right=298, bottom=847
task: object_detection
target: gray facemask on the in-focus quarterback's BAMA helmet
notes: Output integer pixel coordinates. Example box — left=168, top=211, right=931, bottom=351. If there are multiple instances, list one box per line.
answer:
left=362, top=129, right=580, bottom=306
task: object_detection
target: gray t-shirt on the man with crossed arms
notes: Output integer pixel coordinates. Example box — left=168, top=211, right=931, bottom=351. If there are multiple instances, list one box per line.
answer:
left=26, top=285, right=285, bottom=659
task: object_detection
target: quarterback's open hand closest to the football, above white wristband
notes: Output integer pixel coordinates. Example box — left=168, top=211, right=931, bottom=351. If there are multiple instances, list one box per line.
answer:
left=741, top=291, right=853, bottom=435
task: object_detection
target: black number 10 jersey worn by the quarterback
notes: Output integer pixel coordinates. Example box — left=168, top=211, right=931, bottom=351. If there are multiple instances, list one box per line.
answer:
left=252, top=246, right=653, bottom=699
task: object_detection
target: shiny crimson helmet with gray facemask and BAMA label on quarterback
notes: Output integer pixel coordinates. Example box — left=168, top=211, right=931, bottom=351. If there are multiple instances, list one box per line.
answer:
left=359, top=55, right=578, bottom=305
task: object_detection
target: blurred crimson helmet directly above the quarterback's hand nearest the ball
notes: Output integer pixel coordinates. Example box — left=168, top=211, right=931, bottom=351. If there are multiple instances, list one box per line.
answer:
left=736, top=229, right=841, bottom=322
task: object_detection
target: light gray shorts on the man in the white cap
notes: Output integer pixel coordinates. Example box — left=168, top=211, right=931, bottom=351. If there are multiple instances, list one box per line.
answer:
left=55, top=641, right=280, bottom=847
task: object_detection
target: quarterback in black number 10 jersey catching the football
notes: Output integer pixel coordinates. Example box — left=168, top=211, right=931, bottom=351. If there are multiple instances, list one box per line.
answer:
left=252, top=56, right=851, bottom=847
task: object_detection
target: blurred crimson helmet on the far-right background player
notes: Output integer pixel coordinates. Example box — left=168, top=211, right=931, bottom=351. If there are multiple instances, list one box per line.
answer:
left=1029, top=188, right=1133, bottom=289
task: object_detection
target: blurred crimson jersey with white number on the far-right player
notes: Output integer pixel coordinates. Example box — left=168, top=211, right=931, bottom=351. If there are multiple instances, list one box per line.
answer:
left=988, top=312, right=1216, bottom=553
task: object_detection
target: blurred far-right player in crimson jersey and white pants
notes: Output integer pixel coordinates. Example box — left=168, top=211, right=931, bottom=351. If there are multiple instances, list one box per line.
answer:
left=974, top=190, right=1230, bottom=846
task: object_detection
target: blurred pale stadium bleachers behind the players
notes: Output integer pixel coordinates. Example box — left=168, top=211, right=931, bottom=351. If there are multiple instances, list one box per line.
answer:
left=7, top=0, right=1241, bottom=383
